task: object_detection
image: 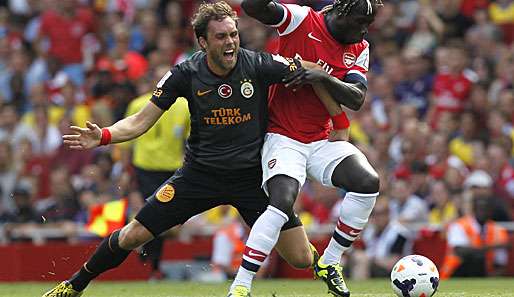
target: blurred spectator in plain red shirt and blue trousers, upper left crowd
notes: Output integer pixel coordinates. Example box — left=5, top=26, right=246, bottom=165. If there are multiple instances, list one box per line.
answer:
left=39, top=0, right=95, bottom=86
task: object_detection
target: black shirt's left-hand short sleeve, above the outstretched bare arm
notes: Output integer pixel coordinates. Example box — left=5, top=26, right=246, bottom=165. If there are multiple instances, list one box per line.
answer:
left=150, top=66, right=189, bottom=110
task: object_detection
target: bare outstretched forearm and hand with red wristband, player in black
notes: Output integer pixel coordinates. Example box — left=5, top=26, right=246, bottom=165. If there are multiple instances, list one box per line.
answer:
left=62, top=102, right=164, bottom=150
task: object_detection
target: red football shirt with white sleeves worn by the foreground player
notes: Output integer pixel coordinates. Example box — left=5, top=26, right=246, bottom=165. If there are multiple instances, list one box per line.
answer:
left=268, top=4, right=369, bottom=143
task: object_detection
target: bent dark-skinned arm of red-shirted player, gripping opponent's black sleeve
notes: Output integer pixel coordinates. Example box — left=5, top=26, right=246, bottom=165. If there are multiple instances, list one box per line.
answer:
left=284, top=69, right=367, bottom=111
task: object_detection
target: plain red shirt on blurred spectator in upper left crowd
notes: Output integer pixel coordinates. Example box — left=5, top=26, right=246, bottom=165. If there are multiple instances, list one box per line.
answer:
left=40, top=8, right=94, bottom=64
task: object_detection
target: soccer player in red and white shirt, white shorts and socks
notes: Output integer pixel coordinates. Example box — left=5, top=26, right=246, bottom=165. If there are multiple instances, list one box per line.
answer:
left=228, top=0, right=382, bottom=297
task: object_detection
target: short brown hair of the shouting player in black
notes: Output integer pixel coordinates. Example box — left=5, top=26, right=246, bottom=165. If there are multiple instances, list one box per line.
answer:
left=191, top=1, right=238, bottom=38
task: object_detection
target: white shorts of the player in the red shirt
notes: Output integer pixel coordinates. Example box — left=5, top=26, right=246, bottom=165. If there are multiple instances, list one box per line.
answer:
left=262, top=133, right=364, bottom=194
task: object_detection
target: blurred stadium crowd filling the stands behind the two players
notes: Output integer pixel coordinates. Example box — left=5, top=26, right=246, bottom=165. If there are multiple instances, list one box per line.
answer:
left=0, top=0, right=514, bottom=278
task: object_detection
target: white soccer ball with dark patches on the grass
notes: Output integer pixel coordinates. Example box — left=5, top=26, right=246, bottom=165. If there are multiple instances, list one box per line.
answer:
left=391, top=255, right=439, bottom=297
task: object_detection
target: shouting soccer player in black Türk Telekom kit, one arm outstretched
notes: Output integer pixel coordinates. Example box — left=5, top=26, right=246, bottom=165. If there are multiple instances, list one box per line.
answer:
left=43, top=2, right=315, bottom=297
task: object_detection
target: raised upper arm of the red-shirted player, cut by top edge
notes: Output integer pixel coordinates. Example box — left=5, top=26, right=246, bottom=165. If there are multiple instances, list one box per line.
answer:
left=241, top=0, right=284, bottom=25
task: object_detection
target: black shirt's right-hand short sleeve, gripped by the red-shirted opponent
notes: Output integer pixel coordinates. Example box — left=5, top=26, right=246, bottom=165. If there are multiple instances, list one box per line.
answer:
left=257, top=53, right=302, bottom=84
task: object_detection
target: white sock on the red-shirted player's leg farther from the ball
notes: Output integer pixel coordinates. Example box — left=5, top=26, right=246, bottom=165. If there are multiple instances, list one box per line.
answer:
left=231, top=205, right=288, bottom=289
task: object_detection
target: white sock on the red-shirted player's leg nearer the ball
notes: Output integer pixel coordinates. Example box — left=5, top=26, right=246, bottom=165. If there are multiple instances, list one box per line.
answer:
left=321, top=192, right=378, bottom=264
